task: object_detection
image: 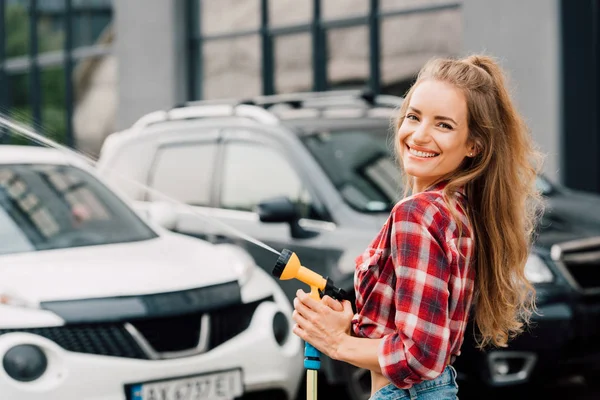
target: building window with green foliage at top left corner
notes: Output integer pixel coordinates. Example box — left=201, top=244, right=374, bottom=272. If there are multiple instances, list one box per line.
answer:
left=0, top=0, right=112, bottom=146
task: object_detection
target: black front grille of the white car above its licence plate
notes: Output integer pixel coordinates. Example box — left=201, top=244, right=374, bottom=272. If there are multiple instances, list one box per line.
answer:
left=0, top=297, right=273, bottom=359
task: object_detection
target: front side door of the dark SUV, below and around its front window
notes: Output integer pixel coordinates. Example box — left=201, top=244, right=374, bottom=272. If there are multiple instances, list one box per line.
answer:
left=179, top=129, right=339, bottom=299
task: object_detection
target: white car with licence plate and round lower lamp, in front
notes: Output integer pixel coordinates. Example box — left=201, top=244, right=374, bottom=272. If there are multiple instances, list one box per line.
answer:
left=0, top=145, right=303, bottom=400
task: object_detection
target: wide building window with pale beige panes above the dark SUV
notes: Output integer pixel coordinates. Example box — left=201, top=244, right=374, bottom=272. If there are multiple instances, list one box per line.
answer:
left=186, top=0, right=461, bottom=100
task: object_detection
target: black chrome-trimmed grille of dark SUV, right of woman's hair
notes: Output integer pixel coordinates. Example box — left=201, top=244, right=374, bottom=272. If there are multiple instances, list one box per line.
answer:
left=551, top=237, right=600, bottom=294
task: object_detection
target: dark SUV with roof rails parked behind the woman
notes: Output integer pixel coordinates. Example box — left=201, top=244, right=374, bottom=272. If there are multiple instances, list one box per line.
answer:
left=98, top=92, right=600, bottom=399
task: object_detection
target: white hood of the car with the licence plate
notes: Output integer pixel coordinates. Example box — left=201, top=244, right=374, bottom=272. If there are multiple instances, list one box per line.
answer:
left=0, top=233, right=238, bottom=303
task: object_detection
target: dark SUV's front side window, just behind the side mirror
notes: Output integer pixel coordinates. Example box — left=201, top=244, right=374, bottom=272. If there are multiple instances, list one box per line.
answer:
left=221, top=142, right=319, bottom=219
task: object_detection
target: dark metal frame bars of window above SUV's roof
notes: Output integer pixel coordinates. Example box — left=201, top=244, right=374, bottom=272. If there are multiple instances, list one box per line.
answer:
left=186, top=0, right=460, bottom=100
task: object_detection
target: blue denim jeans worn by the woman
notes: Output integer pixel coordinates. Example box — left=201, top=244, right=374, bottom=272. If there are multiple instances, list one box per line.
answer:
left=369, top=365, right=458, bottom=400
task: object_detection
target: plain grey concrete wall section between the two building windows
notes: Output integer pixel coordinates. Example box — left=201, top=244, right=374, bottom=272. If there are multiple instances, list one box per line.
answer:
left=113, top=0, right=186, bottom=130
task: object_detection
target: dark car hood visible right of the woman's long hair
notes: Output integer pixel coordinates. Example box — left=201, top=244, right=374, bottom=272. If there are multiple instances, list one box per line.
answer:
left=536, top=191, right=600, bottom=248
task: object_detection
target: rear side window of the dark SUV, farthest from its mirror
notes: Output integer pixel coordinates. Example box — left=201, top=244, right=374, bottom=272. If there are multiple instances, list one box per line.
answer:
left=148, top=142, right=217, bottom=206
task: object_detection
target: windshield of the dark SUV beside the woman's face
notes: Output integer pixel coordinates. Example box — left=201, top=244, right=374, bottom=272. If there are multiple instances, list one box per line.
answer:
left=302, top=129, right=402, bottom=213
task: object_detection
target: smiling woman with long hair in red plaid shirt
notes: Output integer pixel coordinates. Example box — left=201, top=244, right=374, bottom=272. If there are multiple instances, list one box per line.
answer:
left=294, top=56, right=541, bottom=400
